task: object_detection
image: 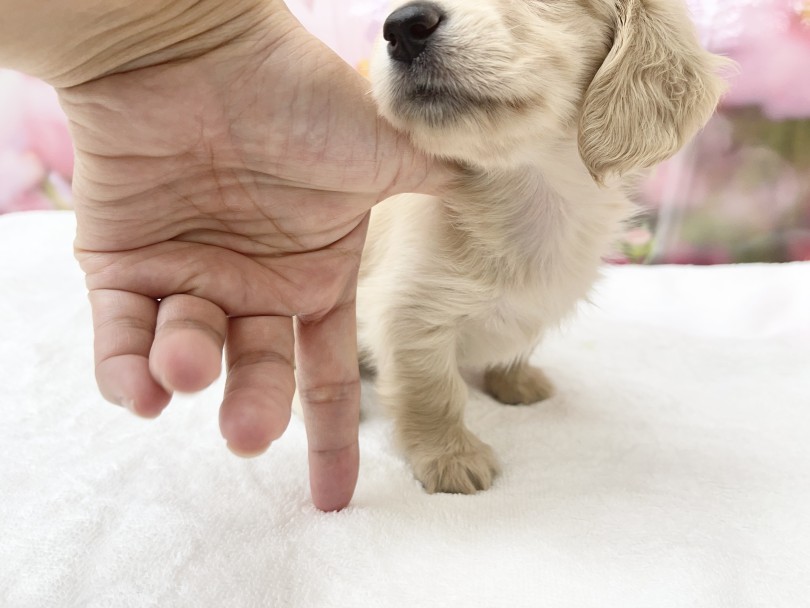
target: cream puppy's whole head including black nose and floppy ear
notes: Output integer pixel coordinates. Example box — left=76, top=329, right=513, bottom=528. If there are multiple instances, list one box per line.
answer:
left=371, top=0, right=722, bottom=180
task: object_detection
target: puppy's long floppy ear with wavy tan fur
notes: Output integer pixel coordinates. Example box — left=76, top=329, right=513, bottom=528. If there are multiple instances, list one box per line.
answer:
left=579, top=0, right=727, bottom=183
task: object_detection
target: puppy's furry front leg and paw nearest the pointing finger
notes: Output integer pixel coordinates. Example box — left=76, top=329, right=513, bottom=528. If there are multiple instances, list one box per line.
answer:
left=377, top=335, right=498, bottom=494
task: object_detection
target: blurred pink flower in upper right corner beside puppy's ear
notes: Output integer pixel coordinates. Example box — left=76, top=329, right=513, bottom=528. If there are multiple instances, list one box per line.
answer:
left=689, top=0, right=810, bottom=120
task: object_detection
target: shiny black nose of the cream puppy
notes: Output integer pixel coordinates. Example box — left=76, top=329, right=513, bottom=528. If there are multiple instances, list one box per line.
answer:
left=383, top=2, right=444, bottom=63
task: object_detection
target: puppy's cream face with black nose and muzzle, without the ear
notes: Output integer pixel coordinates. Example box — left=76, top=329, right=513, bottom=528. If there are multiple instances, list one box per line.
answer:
left=371, top=0, right=610, bottom=166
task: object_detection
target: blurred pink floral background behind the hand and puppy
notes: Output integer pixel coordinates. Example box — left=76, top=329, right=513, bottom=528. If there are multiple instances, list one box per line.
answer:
left=0, top=0, right=810, bottom=264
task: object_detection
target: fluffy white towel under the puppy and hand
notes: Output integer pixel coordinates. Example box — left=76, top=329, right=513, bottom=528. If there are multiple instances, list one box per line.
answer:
left=0, top=212, right=810, bottom=608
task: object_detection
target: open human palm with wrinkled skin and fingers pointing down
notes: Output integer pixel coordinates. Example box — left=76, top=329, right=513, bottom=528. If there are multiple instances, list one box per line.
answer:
left=59, top=11, right=443, bottom=510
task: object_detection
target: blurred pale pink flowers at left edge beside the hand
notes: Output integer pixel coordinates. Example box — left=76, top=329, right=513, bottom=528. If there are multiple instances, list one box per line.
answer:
left=0, top=70, right=73, bottom=213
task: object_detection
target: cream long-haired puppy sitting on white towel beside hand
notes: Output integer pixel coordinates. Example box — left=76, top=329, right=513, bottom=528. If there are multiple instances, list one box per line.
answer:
left=358, top=0, right=723, bottom=493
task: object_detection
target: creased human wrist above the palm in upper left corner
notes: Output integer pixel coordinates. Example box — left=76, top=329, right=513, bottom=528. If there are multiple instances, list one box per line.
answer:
left=0, top=0, right=287, bottom=87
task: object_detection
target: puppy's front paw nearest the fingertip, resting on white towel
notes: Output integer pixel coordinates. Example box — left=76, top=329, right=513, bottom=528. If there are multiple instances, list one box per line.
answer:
left=410, top=432, right=500, bottom=494
